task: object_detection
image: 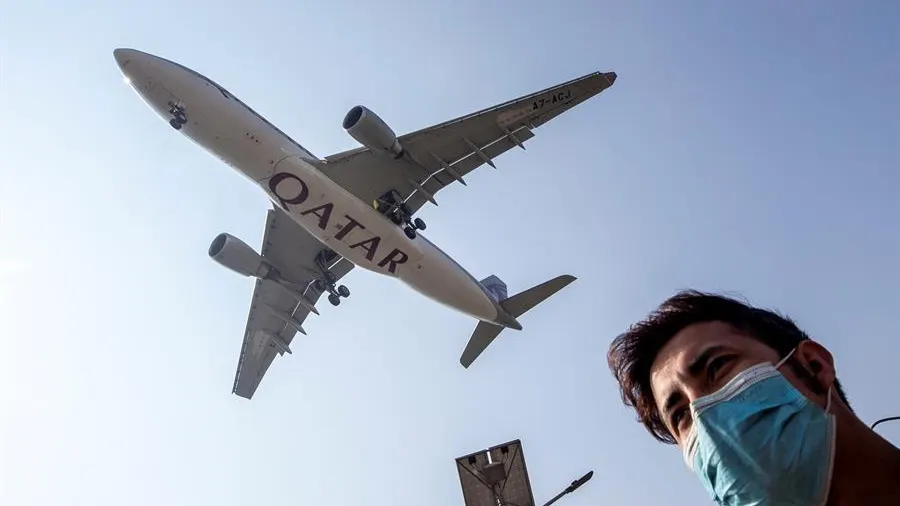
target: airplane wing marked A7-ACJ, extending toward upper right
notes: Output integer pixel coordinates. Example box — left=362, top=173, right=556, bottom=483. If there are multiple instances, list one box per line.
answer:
left=319, top=72, right=616, bottom=213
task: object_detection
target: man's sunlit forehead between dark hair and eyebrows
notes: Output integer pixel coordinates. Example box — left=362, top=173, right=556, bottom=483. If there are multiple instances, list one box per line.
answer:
left=650, top=321, right=762, bottom=399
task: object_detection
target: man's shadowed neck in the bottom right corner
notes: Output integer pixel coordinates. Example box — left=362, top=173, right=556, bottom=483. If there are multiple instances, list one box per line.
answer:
left=828, top=417, right=900, bottom=506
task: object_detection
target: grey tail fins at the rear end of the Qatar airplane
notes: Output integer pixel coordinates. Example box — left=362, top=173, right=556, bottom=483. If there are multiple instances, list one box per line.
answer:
left=459, top=274, right=575, bottom=368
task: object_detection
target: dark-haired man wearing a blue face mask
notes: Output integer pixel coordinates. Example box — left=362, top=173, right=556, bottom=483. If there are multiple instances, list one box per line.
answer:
left=608, top=291, right=900, bottom=506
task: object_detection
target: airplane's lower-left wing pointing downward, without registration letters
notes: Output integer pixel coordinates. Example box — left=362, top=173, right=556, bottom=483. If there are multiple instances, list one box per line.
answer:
left=232, top=207, right=353, bottom=399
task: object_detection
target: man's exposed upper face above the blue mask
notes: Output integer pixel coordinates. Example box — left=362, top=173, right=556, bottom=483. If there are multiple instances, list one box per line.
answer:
left=650, top=322, right=815, bottom=445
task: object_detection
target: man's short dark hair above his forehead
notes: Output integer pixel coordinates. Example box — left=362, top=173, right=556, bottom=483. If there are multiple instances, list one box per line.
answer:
left=607, top=290, right=850, bottom=444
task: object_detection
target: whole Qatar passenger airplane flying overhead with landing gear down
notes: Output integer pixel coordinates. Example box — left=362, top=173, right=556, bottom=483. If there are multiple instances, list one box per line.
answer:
left=113, top=48, right=616, bottom=399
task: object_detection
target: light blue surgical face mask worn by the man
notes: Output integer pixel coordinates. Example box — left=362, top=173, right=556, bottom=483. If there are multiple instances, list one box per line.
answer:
left=683, top=351, right=836, bottom=506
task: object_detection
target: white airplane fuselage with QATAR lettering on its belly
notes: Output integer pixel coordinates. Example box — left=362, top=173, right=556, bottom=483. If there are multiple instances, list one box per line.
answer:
left=115, top=49, right=503, bottom=324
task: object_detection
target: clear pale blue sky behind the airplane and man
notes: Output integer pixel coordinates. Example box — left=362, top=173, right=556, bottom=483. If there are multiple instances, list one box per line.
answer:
left=0, top=0, right=900, bottom=506
